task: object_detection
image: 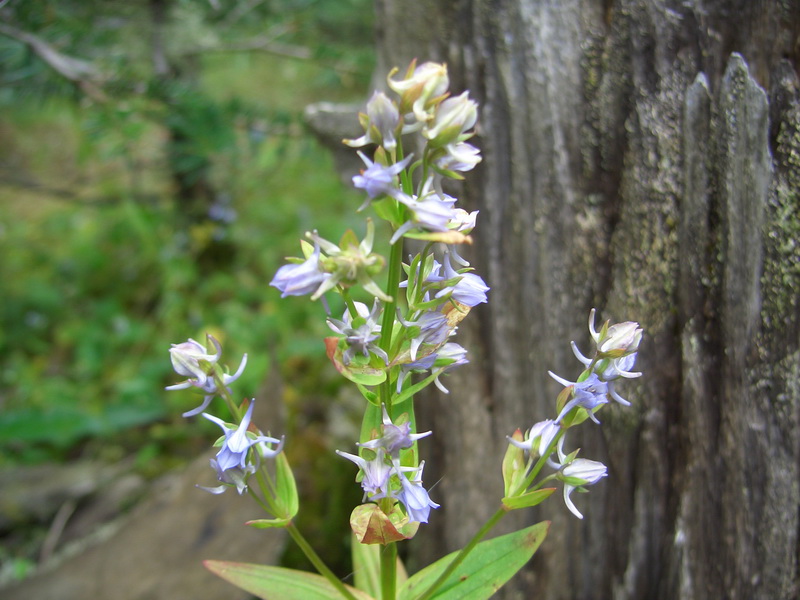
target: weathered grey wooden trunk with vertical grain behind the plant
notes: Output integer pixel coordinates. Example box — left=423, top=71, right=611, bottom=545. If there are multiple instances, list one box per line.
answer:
left=376, top=0, right=800, bottom=600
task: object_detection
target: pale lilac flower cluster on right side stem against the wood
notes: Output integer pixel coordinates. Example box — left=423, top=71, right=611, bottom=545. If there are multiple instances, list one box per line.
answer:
left=507, top=309, right=642, bottom=519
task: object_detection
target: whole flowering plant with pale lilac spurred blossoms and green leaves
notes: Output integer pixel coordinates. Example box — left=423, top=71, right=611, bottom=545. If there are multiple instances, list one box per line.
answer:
left=167, top=62, right=642, bottom=600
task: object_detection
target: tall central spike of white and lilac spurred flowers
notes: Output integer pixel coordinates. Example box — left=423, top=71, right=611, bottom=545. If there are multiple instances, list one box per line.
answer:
left=270, top=62, right=489, bottom=536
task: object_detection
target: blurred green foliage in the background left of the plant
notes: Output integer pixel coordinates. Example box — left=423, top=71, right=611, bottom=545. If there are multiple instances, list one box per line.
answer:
left=0, top=0, right=372, bottom=464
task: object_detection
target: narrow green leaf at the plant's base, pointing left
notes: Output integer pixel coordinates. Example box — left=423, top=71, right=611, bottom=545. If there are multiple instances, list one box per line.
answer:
left=203, top=560, right=374, bottom=600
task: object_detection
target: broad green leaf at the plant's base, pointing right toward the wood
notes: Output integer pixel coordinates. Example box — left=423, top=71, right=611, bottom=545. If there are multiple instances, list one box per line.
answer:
left=398, top=521, right=550, bottom=600
